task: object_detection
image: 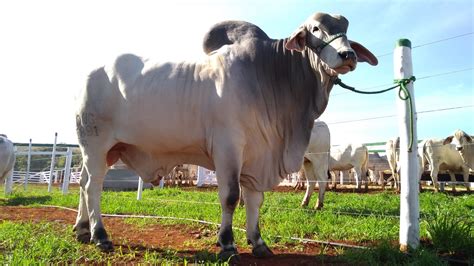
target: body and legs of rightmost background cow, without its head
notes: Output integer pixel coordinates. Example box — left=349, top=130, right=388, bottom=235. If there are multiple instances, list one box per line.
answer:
left=423, top=139, right=469, bottom=192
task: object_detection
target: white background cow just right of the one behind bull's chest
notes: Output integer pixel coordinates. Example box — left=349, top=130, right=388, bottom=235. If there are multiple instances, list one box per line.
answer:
left=329, top=144, right=369, bottom=190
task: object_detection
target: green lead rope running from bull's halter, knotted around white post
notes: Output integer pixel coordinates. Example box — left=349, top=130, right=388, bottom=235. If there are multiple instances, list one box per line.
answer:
left=334, top=76, right=416, bottom=152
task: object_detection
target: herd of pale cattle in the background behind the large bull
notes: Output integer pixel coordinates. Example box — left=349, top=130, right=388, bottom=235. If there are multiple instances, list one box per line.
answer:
left=0, top=125, right=474, bottom=198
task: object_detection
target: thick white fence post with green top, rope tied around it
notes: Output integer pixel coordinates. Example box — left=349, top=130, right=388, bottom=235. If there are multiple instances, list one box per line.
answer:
left=394, top=39, right=420, bottom=251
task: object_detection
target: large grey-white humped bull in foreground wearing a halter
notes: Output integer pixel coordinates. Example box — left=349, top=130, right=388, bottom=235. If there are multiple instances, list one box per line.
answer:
left=74, top=13, right=377, bottom=259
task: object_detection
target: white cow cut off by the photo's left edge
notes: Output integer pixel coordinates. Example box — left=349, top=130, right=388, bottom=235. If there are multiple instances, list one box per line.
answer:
left=0, top=134, right=15, bottom=193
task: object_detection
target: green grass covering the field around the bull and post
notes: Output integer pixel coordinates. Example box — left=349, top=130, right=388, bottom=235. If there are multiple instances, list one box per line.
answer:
left=0, top=186, right=474, bottom=265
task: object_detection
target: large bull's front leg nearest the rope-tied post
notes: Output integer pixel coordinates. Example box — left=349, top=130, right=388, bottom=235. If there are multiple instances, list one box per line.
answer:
left=242, top=187, right=273, bottom=258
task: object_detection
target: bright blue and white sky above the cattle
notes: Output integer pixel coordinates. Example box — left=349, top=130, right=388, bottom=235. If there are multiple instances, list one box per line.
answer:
left=0, top=0, right=474, bottom=144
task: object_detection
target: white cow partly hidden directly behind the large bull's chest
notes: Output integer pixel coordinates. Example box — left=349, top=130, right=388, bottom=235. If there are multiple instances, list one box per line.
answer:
left=301, top=121, right=331, bottom=210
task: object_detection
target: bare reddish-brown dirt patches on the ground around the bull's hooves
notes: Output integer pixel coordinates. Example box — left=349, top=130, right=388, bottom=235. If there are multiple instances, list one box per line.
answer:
left=0, top=206, right=343, bottom=266
